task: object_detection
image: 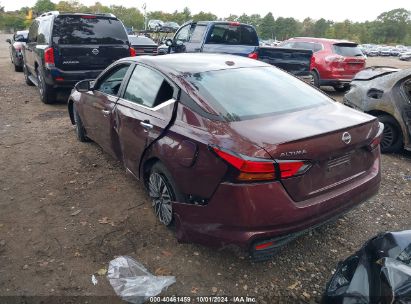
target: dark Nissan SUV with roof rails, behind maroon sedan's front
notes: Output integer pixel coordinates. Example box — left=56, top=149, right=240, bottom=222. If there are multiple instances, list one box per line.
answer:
left=23, top=12, right=135, bottom=103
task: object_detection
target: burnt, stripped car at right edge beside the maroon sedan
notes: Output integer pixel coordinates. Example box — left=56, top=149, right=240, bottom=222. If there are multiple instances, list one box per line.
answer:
left=344, top=67, right=411, bottom=152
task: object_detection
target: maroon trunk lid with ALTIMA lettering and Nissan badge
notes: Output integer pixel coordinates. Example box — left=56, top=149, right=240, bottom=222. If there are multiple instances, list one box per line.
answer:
left=231, top=104, right=379, bottom=202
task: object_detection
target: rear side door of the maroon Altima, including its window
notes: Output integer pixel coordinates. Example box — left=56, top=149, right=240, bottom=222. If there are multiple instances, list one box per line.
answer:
left=115, top=64, right=178, bottom=177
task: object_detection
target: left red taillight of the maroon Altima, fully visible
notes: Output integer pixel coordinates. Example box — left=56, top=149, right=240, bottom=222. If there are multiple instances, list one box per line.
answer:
left=212, top=147, right=311, bottom=181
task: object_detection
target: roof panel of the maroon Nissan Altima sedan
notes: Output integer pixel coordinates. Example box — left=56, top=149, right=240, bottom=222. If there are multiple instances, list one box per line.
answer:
left=120, top=53, right=271, bottom=77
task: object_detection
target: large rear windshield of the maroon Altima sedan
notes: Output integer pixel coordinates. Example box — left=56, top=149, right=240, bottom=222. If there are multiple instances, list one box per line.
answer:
left=189, top=67, right=330, bottom=121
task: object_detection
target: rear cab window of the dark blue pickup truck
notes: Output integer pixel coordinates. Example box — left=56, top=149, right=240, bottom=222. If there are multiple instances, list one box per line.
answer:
left=206, top=24, right=258, bottom=46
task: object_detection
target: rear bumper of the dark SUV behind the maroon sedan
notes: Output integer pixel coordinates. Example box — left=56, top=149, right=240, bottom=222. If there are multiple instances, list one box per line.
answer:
left=46, top=68, right=102, bottom=88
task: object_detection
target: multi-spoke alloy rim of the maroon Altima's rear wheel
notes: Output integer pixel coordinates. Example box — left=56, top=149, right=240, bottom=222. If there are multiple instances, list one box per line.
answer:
left=148, top=172, right=173, bottom=226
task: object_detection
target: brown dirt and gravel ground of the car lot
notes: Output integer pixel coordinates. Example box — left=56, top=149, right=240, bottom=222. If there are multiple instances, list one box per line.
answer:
left=0, top=35, right=411, bottom=303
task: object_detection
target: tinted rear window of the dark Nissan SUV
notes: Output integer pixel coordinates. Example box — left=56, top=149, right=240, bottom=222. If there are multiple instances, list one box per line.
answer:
left=53, top=16, right=128, bottom=44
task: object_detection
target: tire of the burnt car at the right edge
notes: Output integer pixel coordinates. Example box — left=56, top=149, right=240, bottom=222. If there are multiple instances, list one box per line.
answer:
left=378, top=115, right=403, bottom=153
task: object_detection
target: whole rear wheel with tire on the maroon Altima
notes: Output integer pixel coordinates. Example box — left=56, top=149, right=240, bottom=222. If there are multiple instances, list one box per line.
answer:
left=146, top=162, right=182, bottom=226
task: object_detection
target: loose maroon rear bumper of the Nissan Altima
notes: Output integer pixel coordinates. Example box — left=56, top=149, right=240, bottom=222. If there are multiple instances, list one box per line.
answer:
left=173, top=150, right=381, bottom=256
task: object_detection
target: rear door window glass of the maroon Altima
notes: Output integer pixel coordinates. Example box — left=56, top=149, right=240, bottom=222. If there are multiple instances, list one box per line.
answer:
left=123, top=65, right=174, bottom=108
